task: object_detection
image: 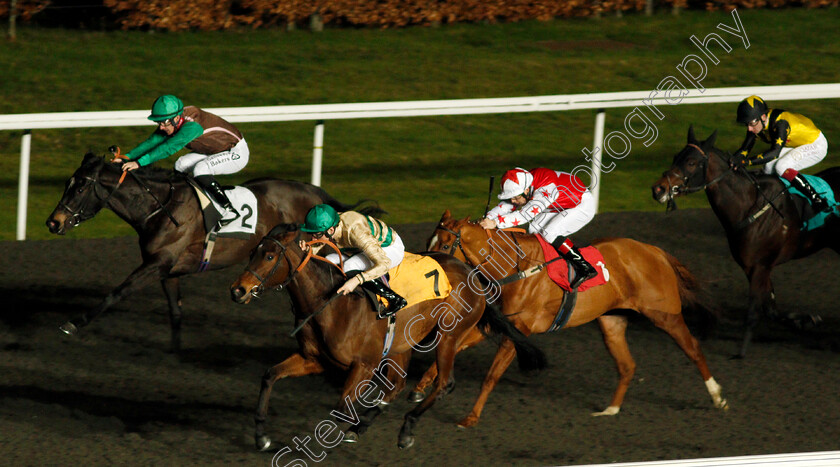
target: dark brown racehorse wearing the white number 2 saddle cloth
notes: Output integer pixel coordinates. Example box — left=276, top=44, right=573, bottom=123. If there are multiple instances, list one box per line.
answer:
left=47, top=154, right=368, bottom=352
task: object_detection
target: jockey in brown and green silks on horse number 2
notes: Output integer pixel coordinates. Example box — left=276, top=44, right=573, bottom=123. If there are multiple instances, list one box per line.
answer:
left=118, top=95, right=250, bottom=226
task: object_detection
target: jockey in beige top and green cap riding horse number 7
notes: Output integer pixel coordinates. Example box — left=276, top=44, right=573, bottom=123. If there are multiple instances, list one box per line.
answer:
left=300, top=204, right=406, bottom=318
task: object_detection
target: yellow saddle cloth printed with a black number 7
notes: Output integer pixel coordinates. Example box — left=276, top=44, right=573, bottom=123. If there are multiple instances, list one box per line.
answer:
left=380, top=252, right=452, bottom=306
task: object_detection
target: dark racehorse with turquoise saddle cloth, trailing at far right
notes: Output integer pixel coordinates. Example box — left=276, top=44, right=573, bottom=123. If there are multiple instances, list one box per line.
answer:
left=652, top=127, right=840, bottom=358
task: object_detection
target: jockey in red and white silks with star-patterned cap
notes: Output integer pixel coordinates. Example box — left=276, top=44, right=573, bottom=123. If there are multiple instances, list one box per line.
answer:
left=479, top=167, right=597, bottom=289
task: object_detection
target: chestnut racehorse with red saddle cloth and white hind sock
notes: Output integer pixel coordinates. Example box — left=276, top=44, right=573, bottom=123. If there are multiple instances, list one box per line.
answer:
left=420, top=210, right=728, bottom=427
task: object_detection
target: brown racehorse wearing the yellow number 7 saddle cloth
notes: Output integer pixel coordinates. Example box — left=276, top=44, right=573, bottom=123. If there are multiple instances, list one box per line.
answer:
left=231, top=225, right=545, bottom=450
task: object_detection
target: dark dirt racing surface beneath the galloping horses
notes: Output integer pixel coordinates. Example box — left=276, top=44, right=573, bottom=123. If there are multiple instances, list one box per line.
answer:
left=0, top=210, right=840, bottom=466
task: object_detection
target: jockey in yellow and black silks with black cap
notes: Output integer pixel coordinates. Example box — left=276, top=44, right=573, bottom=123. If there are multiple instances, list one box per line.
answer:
left=736, top=96, right=830, bottom=211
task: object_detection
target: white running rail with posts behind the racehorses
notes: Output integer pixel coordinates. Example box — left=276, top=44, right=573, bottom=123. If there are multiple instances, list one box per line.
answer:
left=0, top=83, right=840, bottom=240
